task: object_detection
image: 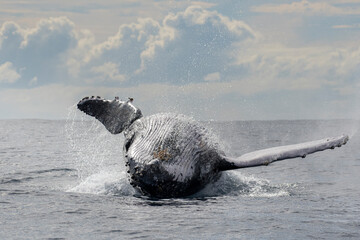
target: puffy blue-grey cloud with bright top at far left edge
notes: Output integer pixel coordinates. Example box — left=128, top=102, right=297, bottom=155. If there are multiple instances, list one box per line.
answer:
left=0, top=17, right=78, bottom=87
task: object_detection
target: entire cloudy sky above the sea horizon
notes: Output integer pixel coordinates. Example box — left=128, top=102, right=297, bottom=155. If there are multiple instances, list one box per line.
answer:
left=0, top=0, right=360, bottom=121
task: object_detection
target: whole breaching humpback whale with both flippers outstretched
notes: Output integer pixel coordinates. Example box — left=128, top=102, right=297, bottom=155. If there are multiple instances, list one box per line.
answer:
left=77, top=96, right=349, bottom=198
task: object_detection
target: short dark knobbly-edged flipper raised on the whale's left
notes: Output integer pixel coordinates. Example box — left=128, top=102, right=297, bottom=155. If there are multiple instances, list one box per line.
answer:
left=77, top=97, right=142, bottom=134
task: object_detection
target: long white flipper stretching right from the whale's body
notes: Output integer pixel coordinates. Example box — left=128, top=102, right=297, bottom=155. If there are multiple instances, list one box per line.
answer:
left=220, top=135, right=349, bottom=171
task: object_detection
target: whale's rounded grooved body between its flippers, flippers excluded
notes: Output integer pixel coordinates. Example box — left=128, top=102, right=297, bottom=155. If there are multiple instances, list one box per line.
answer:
left=124, top=114, right=224, bottom=197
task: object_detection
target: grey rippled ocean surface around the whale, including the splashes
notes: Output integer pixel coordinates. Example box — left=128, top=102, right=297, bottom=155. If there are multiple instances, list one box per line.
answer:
left=0, top=113, right=360, bottom=239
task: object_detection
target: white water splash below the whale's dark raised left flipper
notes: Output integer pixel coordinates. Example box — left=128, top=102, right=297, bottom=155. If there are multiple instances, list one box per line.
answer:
left=65, top=105, right=133, bottom=195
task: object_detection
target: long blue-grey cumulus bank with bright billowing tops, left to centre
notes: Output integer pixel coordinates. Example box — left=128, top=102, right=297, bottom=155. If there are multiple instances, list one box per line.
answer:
left=0, top=6, right=257, bottom=87
